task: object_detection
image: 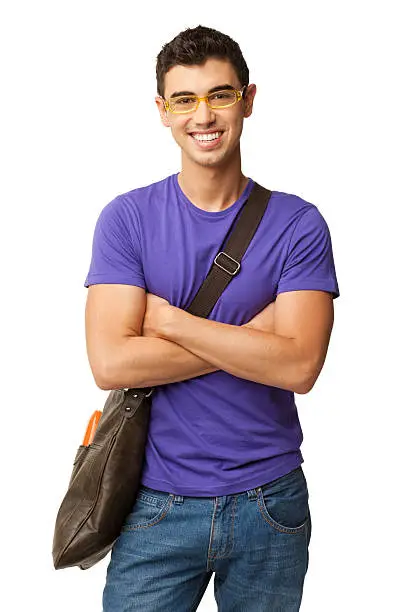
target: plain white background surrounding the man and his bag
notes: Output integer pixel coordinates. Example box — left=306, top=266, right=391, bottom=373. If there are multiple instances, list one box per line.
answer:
left=0, top=0, right=397, bottom=612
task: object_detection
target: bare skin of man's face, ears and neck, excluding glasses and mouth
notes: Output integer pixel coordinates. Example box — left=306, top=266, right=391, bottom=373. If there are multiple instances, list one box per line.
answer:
left=156, top=59, right=256, bottom=212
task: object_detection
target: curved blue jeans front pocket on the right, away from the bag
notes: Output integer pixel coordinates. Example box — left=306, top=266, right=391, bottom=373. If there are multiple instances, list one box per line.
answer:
left=258, top=467, right=310, bottom=533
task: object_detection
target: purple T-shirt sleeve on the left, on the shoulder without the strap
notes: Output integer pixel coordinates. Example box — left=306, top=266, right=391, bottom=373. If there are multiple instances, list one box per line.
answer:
left=84, top=198, right=146, bottom=289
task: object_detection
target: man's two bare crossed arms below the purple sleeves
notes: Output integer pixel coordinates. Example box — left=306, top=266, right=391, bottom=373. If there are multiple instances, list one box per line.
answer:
left=86, top=285, right=333, bottom=393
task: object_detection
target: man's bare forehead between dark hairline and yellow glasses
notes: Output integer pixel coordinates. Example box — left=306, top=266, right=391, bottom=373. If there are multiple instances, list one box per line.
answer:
left=164, top=58, right=241, bottom=98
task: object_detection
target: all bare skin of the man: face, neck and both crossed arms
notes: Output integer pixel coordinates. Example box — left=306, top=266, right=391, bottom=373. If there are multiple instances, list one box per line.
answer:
left=86, top=59, right=333, bottom=393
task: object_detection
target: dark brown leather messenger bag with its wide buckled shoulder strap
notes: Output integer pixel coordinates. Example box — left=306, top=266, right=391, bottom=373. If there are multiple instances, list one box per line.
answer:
left=52, top=183, right=271, bottom=569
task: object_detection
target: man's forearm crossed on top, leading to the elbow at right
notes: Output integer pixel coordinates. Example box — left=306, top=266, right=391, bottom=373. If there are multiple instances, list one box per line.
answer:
left=160, top=309, right=306, bottom=393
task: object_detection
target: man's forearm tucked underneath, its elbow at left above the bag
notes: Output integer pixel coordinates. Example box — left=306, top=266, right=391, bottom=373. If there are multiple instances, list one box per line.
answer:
left=101, top=336, right=218, bottom=389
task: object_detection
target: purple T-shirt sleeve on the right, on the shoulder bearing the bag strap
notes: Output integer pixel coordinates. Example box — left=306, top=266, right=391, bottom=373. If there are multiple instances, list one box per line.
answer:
left=277, top=206, right=339, bottom=299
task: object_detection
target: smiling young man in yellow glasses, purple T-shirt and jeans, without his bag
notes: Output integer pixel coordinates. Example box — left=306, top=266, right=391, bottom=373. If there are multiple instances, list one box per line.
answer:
left=85, top=26, right=339, bottom=612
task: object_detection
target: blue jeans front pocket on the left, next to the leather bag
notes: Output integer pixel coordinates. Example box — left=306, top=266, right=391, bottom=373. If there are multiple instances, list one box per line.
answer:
left=122, top=487, right=174, bottom=531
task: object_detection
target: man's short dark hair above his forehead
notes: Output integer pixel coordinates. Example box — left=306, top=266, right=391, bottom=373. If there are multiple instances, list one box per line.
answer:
left=156, top=25, right=249, bottom=97
